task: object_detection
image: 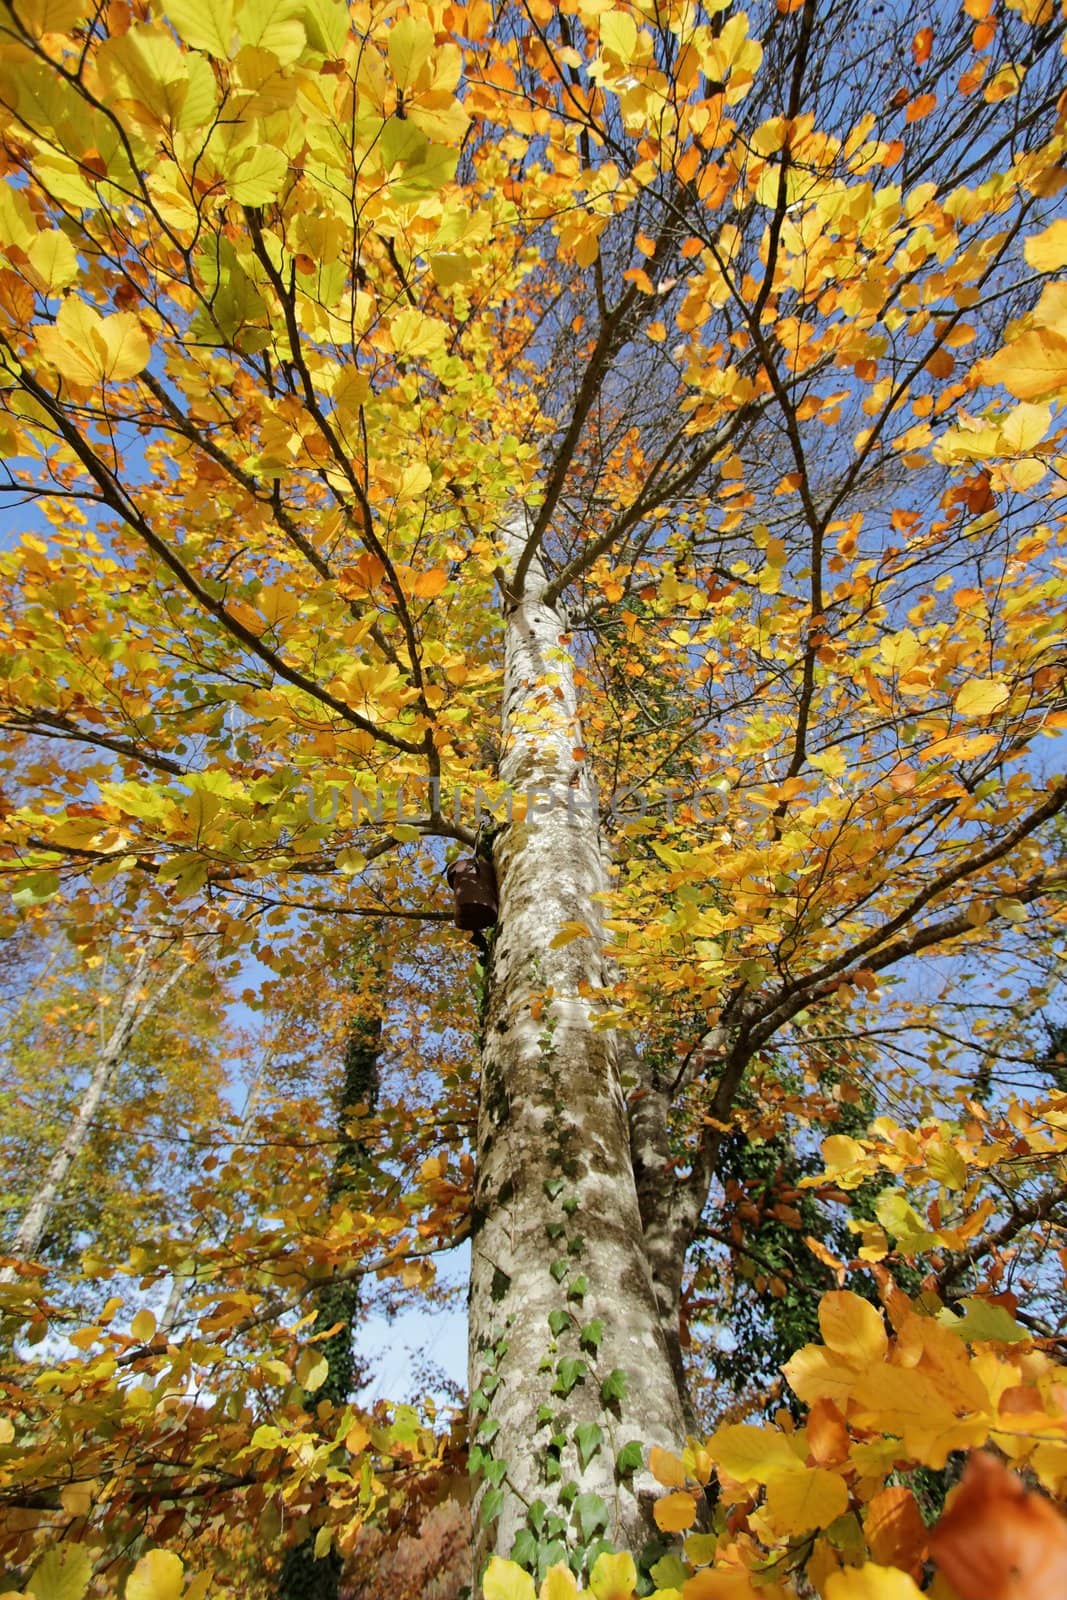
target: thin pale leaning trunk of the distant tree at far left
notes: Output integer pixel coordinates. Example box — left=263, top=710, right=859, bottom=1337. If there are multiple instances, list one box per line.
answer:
left=0, top=949, right=189, bottom=1283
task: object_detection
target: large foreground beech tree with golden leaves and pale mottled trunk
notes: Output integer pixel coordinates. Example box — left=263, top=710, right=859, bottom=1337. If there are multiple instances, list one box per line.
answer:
left=0, top=0, right=1067, bottom=1600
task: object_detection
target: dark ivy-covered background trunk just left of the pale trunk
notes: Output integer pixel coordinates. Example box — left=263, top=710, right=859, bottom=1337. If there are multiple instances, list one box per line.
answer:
left=278, top=938, right=384, bottom=1600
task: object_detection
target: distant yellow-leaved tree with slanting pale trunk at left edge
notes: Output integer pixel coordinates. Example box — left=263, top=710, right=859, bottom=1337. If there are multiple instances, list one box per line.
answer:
left=0, top=930, right=222, bottom=1283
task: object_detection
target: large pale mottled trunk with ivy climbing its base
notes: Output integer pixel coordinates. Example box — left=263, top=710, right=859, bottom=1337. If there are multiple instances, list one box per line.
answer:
left=469, top=534, right=685, bottom=1579
